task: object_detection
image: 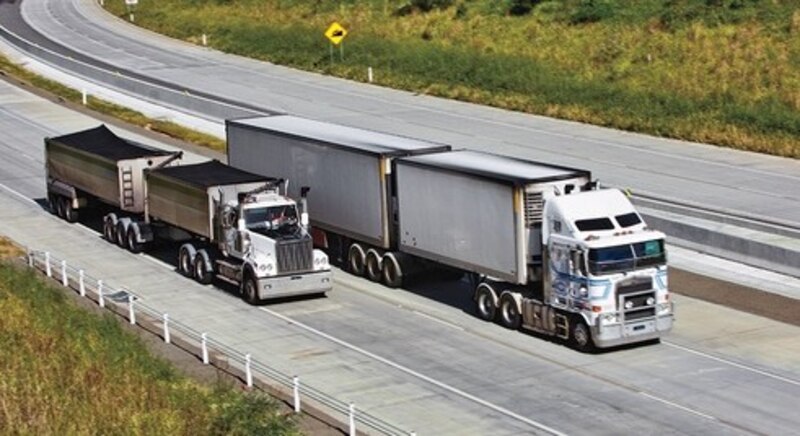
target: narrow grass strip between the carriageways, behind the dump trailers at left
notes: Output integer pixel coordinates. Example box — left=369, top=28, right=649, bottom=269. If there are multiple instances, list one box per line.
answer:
left=0, top=55, right=225, bottom=151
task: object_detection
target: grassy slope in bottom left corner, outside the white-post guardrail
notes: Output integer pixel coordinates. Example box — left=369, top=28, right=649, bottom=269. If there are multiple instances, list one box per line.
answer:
left=0, top=238, right=299, bottom=435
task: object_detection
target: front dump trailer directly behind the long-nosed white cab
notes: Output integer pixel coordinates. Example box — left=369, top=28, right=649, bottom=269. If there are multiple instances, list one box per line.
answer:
left=145, top=161, right=276, bottom=242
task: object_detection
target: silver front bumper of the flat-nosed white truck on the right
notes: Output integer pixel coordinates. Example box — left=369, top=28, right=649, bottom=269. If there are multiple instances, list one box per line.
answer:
left=592, top=313, right=674, bottom=348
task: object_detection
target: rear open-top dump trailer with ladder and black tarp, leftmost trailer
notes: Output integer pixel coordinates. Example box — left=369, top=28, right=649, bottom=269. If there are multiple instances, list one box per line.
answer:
left=45, top=125, right=176, bottom=221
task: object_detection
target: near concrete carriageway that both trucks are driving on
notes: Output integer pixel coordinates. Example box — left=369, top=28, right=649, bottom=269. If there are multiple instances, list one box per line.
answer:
left=0, top=74, right=800, bottom=435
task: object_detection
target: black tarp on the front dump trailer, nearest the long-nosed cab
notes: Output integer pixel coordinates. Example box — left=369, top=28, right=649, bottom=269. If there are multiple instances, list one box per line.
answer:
left=153, top=160, right=277, bottom=188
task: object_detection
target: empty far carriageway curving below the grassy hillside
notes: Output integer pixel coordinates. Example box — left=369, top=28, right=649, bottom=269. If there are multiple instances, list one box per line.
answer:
left=0, top=0, right=800, bottom=225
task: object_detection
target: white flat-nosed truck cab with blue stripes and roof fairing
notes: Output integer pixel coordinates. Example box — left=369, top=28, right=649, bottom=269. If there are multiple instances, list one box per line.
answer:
left=542, top=189, right=673, bottom=348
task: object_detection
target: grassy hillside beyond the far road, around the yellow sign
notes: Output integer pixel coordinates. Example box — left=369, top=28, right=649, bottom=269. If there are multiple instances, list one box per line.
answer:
left=105, top=0, right=800, bottom=158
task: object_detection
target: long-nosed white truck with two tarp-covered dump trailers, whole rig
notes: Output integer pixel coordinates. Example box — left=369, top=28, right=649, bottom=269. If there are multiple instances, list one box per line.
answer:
left=45, top=126, right=332, bottom=304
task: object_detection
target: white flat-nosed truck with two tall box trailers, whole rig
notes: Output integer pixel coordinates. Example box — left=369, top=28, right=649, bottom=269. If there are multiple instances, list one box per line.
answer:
left=227, top=115, right=673, bottom=350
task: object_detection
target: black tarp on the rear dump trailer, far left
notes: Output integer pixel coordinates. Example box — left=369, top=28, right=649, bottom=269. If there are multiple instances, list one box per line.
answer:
left=50, top=124, right=169, bottom=161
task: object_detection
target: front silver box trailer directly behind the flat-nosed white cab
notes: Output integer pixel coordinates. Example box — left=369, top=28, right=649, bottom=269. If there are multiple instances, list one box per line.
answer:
left=394, top=151, right=590, bottom=284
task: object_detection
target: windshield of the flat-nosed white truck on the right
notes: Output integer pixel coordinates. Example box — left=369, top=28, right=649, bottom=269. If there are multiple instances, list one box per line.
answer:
left=589, top=239, right=667, bottom=274
